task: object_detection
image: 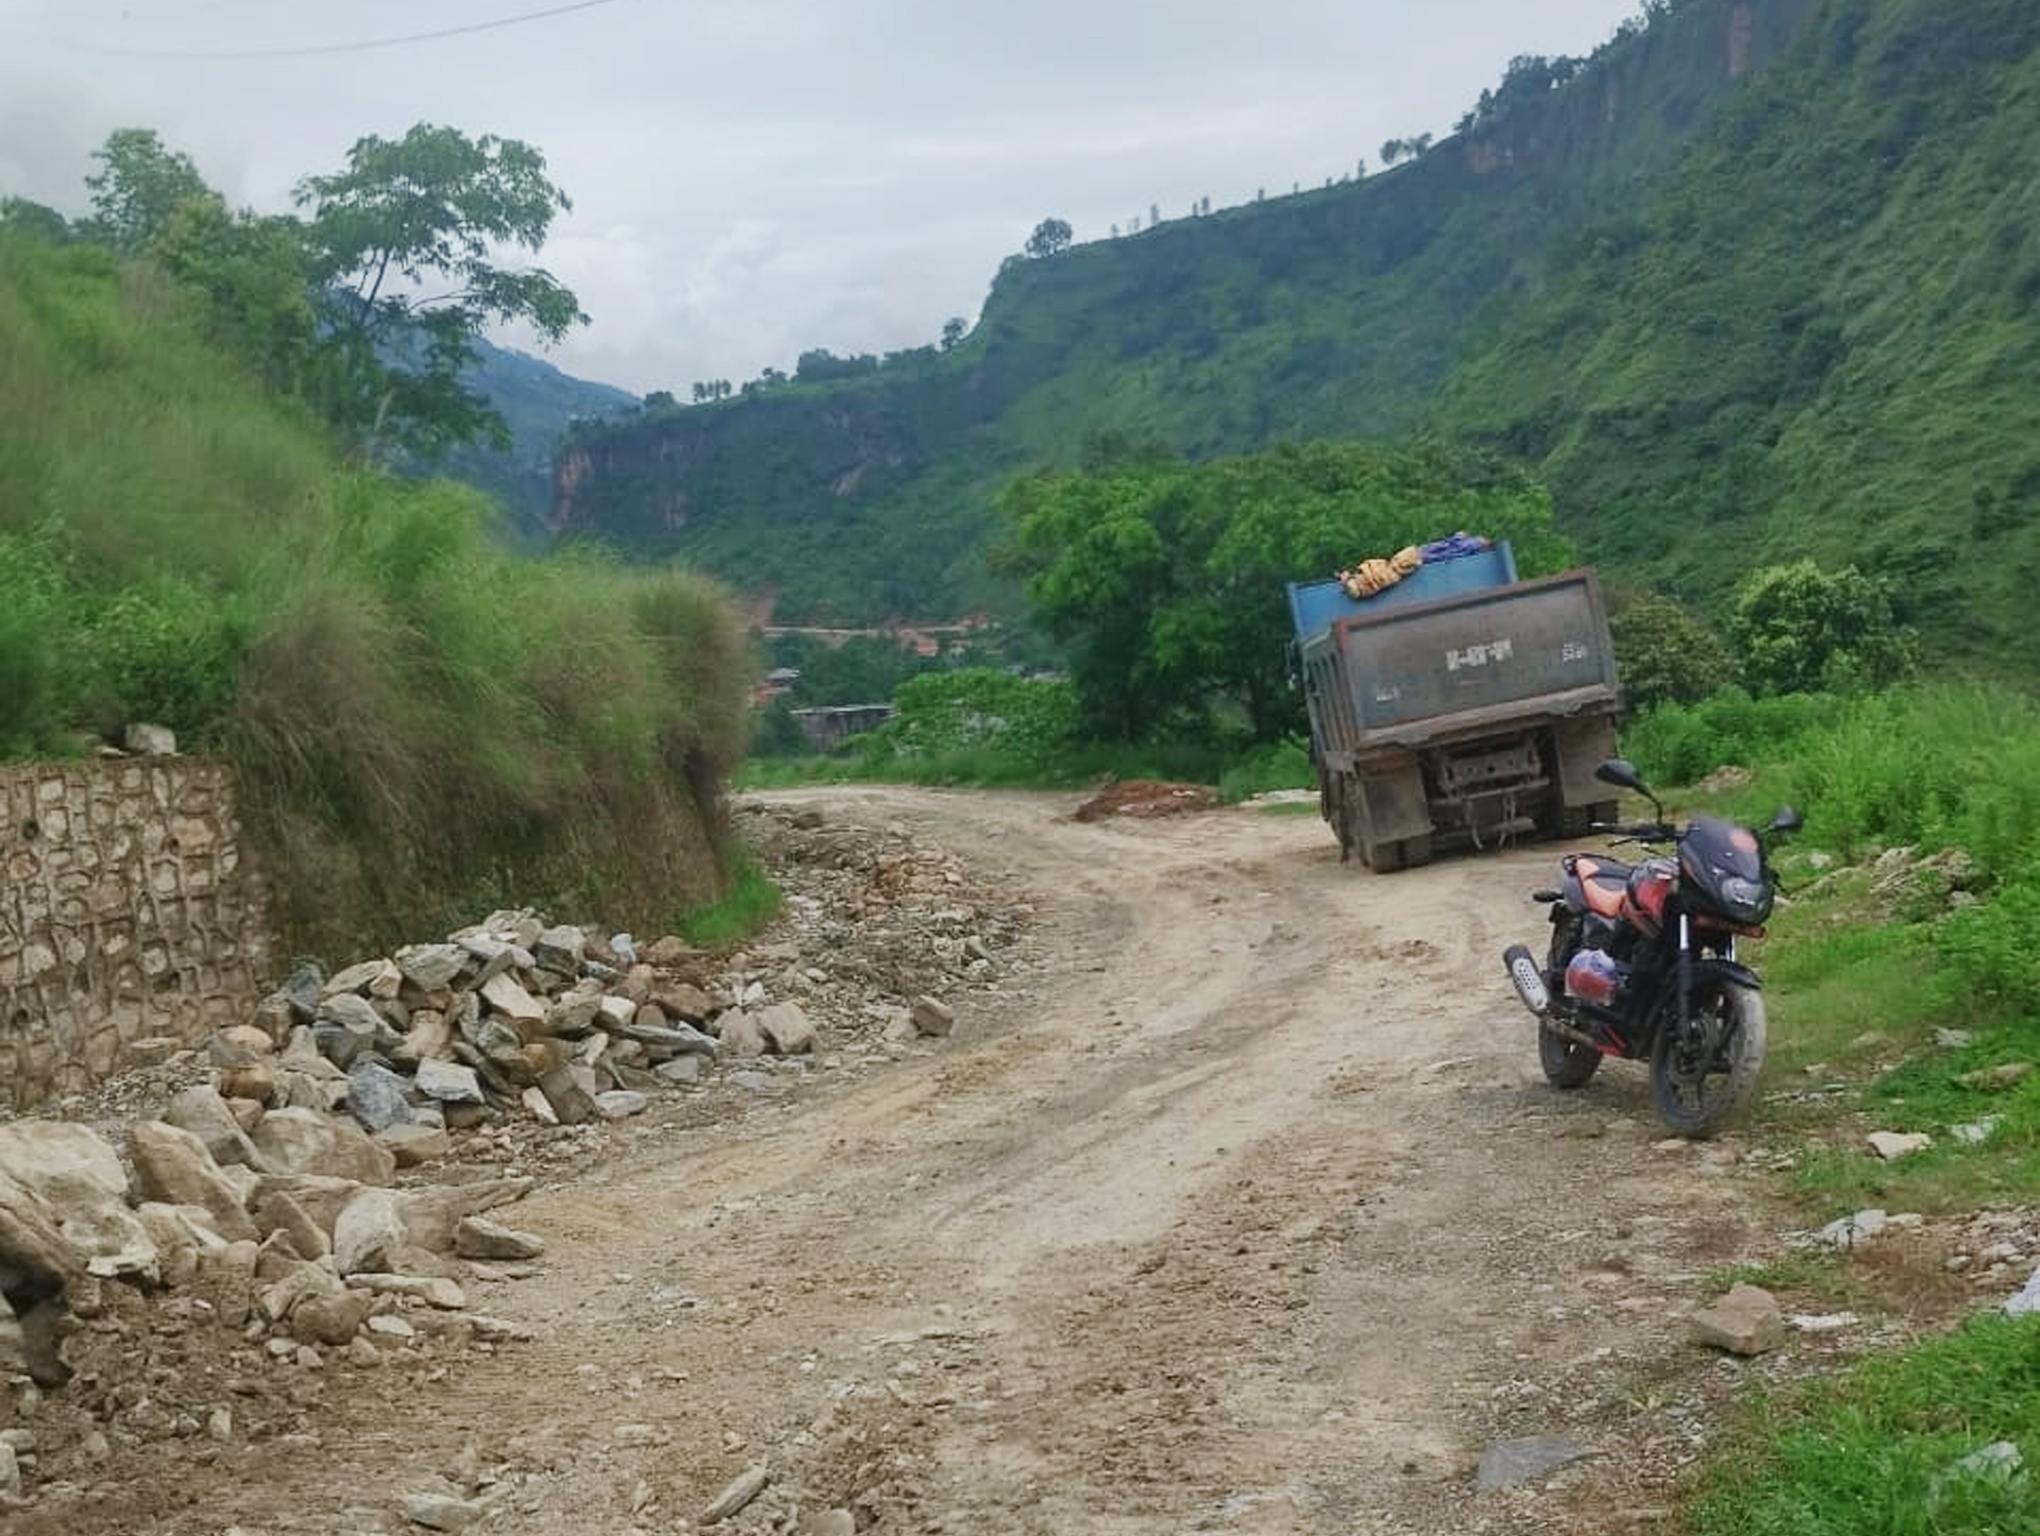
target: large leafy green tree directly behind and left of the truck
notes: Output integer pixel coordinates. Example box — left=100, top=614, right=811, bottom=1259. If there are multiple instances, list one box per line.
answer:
left=1000, top=437, right=1563, bottom=740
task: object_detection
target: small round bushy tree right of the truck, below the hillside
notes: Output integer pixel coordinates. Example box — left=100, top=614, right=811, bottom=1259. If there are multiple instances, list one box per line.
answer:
left=1728, top=561, right=1916, bottom=694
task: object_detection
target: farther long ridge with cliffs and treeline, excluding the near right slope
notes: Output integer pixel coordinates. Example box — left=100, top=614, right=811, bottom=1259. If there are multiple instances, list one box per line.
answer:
left=557, top=0, right=1814, bottom=616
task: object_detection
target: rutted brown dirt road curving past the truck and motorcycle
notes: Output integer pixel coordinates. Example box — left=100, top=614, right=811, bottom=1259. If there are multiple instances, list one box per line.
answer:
left=31, top=789, right=1787, bottom=1536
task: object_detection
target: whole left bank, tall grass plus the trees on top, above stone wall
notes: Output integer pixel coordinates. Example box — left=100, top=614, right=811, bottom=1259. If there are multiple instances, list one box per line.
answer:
left=0, top=133, right=755, bottom=955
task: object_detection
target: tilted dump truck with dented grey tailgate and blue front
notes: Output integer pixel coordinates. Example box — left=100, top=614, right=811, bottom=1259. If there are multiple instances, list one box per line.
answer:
left=1289, top=543, right=1620, bottom=873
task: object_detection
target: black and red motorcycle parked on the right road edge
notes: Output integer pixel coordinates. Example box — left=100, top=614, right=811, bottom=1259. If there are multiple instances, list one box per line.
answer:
left=1503, top=759, right=1801, bottom=1136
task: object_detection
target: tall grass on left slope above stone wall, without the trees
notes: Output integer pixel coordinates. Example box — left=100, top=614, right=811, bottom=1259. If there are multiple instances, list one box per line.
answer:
left=0, top=237, right=755, bottom=957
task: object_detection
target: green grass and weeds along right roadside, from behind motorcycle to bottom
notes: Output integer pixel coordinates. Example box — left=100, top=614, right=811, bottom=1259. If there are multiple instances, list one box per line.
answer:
left=1624, top=683, right=2040, bottom=1536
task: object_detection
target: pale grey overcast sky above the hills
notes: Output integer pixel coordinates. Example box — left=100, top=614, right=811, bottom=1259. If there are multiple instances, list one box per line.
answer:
left=0, top=0, right=1638, bottom=398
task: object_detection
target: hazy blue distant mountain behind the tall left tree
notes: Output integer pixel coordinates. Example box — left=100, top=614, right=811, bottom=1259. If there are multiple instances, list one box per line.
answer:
left=437, top=341, right=641, bottom=545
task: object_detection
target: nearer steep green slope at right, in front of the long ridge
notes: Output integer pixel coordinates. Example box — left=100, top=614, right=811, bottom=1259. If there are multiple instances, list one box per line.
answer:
left=1434, top=0, right=2040, bottom=651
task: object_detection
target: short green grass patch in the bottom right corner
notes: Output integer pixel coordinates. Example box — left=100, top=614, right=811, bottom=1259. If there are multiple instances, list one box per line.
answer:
left=1687, top=1318, right=2040, bottom=1536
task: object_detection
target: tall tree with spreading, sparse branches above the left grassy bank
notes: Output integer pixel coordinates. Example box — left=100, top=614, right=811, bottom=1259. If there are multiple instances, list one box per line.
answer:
left=294, top=122, right=588, bottom=455
